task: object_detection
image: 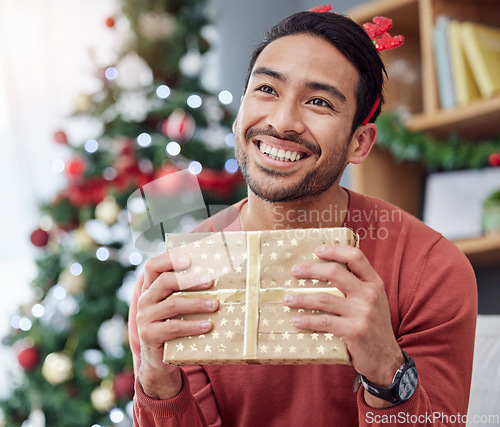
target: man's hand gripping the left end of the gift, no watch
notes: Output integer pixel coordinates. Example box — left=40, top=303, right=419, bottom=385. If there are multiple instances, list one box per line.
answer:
left=137, top=254, right=219, bottom=399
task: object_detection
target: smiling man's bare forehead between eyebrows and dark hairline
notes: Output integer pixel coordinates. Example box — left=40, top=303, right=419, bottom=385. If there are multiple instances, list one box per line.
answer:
left=253, top=34, right=359, bottom=98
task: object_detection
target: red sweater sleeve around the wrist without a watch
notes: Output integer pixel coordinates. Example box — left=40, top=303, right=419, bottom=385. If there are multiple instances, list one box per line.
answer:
left=128, top=275, right=221, bottom=427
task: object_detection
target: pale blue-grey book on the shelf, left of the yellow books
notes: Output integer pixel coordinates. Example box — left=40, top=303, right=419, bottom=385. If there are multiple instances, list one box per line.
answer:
left=432, top=15, right=457, bottom=110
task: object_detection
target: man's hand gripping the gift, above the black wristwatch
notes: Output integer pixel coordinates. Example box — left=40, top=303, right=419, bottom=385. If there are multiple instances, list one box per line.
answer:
left=285, top=245, right=404, bottom=408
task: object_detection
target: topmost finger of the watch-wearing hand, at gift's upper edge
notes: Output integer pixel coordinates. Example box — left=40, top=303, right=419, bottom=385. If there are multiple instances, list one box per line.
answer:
left=315, top=245, right=379, bottom=282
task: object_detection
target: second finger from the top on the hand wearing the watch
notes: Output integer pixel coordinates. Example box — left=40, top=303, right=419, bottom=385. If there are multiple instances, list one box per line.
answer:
left=292, top=262, right=360, bottom=295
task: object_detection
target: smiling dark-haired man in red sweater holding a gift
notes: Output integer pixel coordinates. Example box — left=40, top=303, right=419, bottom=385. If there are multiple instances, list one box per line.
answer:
left=130, top=12, right=477, bottom=427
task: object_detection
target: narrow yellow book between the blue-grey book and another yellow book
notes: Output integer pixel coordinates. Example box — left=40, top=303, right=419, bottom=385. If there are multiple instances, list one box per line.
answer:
left=448, top=19, right=481, bottom=106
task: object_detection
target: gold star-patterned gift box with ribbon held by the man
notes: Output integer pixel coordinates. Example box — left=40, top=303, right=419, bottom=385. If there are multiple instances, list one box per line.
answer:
left=163, top=228, right=358, bottom=365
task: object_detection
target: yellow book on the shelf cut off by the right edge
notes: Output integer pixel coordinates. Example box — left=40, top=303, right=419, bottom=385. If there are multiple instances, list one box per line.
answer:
left=461, top=22, right=500, bottom=98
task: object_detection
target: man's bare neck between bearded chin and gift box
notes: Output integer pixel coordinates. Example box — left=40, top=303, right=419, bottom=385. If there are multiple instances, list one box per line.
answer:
left=241, top=184, right=349, bottom=231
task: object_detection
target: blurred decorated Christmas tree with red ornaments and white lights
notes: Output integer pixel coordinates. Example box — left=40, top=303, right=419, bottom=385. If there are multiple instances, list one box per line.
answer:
left=0, top=0, right=245, bottom=427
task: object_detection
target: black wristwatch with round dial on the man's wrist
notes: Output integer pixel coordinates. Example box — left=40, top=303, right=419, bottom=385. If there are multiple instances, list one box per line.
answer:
left=359, top=351, right=418, bottom=403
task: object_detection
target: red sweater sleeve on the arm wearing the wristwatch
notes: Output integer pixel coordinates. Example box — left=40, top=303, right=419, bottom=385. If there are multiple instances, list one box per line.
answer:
left=357, top=238, right=477, bottom=426
